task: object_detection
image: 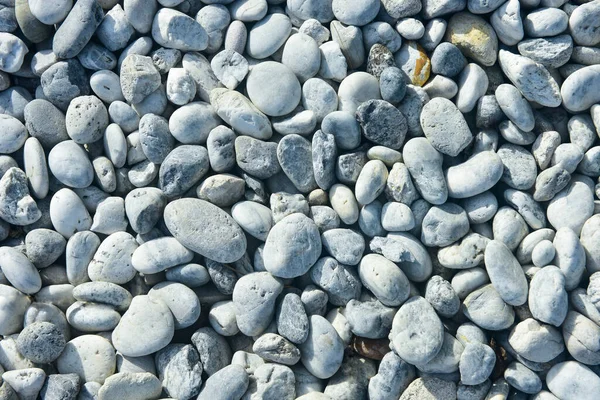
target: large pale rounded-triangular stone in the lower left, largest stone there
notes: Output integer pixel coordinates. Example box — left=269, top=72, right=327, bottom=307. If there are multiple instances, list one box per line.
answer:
left=112, top=295, right=175, bottom=357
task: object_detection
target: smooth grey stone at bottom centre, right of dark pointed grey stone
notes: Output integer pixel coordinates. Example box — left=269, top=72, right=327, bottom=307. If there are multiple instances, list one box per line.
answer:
left=298, top=315, right=344, bottom=379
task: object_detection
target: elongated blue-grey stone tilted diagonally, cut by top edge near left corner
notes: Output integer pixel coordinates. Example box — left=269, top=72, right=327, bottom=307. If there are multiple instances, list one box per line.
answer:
left=52, top=0, right=104, bottom=58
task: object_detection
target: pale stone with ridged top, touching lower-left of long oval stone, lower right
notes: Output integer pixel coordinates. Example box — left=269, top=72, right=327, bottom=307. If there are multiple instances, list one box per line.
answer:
left=463, top=285, right=515, bottom=331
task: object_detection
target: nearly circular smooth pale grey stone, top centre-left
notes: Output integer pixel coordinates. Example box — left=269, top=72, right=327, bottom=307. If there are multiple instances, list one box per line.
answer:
left=246, top=61, right=301, bottom=117
